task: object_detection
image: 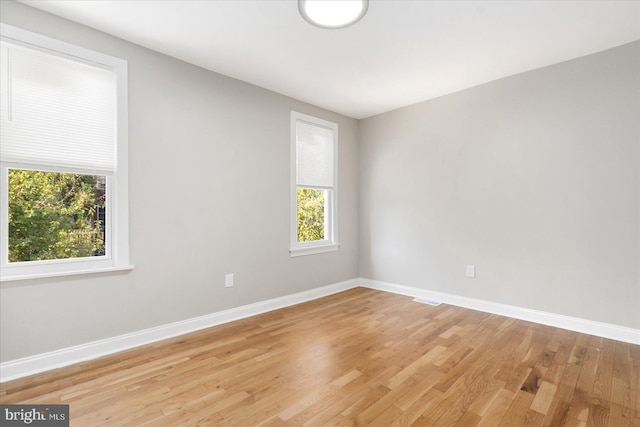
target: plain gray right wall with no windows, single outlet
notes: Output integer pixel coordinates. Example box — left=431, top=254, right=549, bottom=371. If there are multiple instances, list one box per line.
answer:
left=360, top=42, right=640, bottom=328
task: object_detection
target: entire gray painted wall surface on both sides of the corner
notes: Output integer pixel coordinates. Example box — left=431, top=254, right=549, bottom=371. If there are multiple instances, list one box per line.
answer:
left=0, top=1, right=640, bottom=361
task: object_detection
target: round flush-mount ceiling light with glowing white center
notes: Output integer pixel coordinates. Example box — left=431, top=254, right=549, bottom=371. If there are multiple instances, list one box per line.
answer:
left=298, top=0, right=369, bottom=29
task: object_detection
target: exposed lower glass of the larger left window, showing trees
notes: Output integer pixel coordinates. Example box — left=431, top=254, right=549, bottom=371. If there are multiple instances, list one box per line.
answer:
left=8, top=169, right=106, bottom=262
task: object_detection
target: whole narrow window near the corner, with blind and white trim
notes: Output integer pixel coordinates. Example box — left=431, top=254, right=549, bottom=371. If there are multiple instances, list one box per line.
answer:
left=290, top=111, right=339, bottom=256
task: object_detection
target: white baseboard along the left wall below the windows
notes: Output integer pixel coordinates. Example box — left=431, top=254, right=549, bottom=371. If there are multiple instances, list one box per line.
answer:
left=0, top=279, right=359, bottom=382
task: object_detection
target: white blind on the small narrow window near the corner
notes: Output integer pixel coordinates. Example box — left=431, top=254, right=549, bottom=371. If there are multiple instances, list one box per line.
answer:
left=296, top=120, right=334, bottom=188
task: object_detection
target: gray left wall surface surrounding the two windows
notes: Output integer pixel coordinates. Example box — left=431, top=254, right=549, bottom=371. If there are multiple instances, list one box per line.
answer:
left=0, top=1, right=358, bottom=361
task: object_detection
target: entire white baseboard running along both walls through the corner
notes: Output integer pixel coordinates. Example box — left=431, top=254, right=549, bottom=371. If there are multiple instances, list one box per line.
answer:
left=0, top=279, right=640, bottom=382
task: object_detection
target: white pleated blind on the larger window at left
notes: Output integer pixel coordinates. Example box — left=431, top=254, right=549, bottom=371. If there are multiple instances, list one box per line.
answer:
left=0, top=41, right=117, bottom=173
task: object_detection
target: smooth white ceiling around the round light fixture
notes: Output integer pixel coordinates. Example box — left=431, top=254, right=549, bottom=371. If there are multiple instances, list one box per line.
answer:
left=17, top=0, right=640, bottom=118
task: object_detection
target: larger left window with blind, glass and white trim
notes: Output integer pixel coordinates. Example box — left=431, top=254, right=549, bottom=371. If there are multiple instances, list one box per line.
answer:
left=0, top=24, right=132, bottom=281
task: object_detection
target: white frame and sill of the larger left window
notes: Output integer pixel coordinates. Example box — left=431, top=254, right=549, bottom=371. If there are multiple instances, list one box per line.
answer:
left=0, top=23, right=133, bottom=282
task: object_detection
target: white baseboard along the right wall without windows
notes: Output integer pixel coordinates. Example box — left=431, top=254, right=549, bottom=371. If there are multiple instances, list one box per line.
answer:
left=359, top=279, right=640, bottom=345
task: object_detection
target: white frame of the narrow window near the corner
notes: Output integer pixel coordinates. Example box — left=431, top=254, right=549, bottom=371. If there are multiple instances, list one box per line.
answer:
left=289, top=111, right=340, bottom=257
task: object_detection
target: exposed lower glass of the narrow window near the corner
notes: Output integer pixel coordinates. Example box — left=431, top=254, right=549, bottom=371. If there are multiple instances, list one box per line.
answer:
left=298, top=188, right=326, bottom=242
